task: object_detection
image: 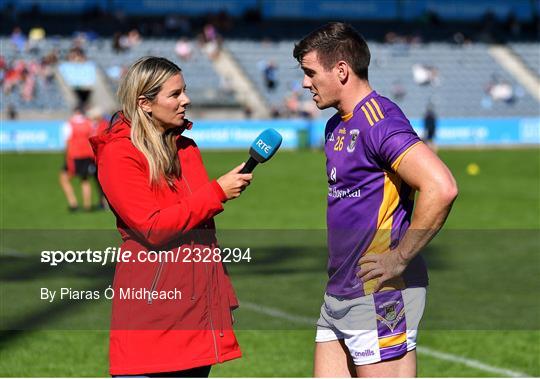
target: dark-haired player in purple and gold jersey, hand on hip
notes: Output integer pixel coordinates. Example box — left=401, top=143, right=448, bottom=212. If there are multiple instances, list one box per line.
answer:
left=293, top=23, right=457, bottom=377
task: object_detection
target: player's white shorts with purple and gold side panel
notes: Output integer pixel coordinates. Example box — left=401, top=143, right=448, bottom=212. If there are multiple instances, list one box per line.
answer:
left=315, top=287, right=426, bottom=366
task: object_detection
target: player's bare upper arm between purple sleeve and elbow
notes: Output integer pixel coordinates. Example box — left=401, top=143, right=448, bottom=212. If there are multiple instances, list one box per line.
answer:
left=397, top=143, right=456, bottom=191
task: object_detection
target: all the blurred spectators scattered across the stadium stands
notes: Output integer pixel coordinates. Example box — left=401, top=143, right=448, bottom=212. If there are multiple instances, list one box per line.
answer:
left=0, top=5, right=538, bottom=118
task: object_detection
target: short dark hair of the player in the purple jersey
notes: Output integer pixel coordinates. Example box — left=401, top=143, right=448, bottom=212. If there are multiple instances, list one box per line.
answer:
left=293, top=22, right=371, bottom=80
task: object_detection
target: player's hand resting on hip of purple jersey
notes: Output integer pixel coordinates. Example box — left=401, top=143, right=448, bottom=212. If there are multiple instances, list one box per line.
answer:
left=356, top=249, right=408, bottom=292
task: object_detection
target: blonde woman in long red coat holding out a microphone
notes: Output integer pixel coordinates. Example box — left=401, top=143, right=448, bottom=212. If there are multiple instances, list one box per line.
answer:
left=92, top=57, right=252, bottom=377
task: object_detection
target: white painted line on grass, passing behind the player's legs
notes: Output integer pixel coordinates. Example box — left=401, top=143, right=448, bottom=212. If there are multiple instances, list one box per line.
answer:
left=240, top=301, right=530, bottom=378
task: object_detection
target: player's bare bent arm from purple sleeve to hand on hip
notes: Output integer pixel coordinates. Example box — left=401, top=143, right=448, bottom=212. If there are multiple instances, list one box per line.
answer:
left=358, top=143, right=458, bottom=291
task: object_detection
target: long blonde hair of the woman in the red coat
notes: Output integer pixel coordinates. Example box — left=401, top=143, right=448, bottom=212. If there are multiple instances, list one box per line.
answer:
left=117, top=57, right=182, bottom=186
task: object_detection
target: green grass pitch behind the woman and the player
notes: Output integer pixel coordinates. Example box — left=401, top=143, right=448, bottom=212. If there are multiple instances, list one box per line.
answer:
left=0, top=149, right=540, bottom=377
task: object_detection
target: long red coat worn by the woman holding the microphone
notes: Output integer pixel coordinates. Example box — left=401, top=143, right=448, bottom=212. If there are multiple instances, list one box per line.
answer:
left=91, top=115, right=241, bottom=375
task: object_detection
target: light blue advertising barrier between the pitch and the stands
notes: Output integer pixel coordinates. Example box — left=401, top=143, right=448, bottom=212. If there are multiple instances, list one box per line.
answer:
left=0, top=117, right=540, bottom=152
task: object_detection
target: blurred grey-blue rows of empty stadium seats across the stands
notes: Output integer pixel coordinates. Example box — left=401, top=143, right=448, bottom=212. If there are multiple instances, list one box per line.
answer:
left=0, top=37, right=540, bottom=117
